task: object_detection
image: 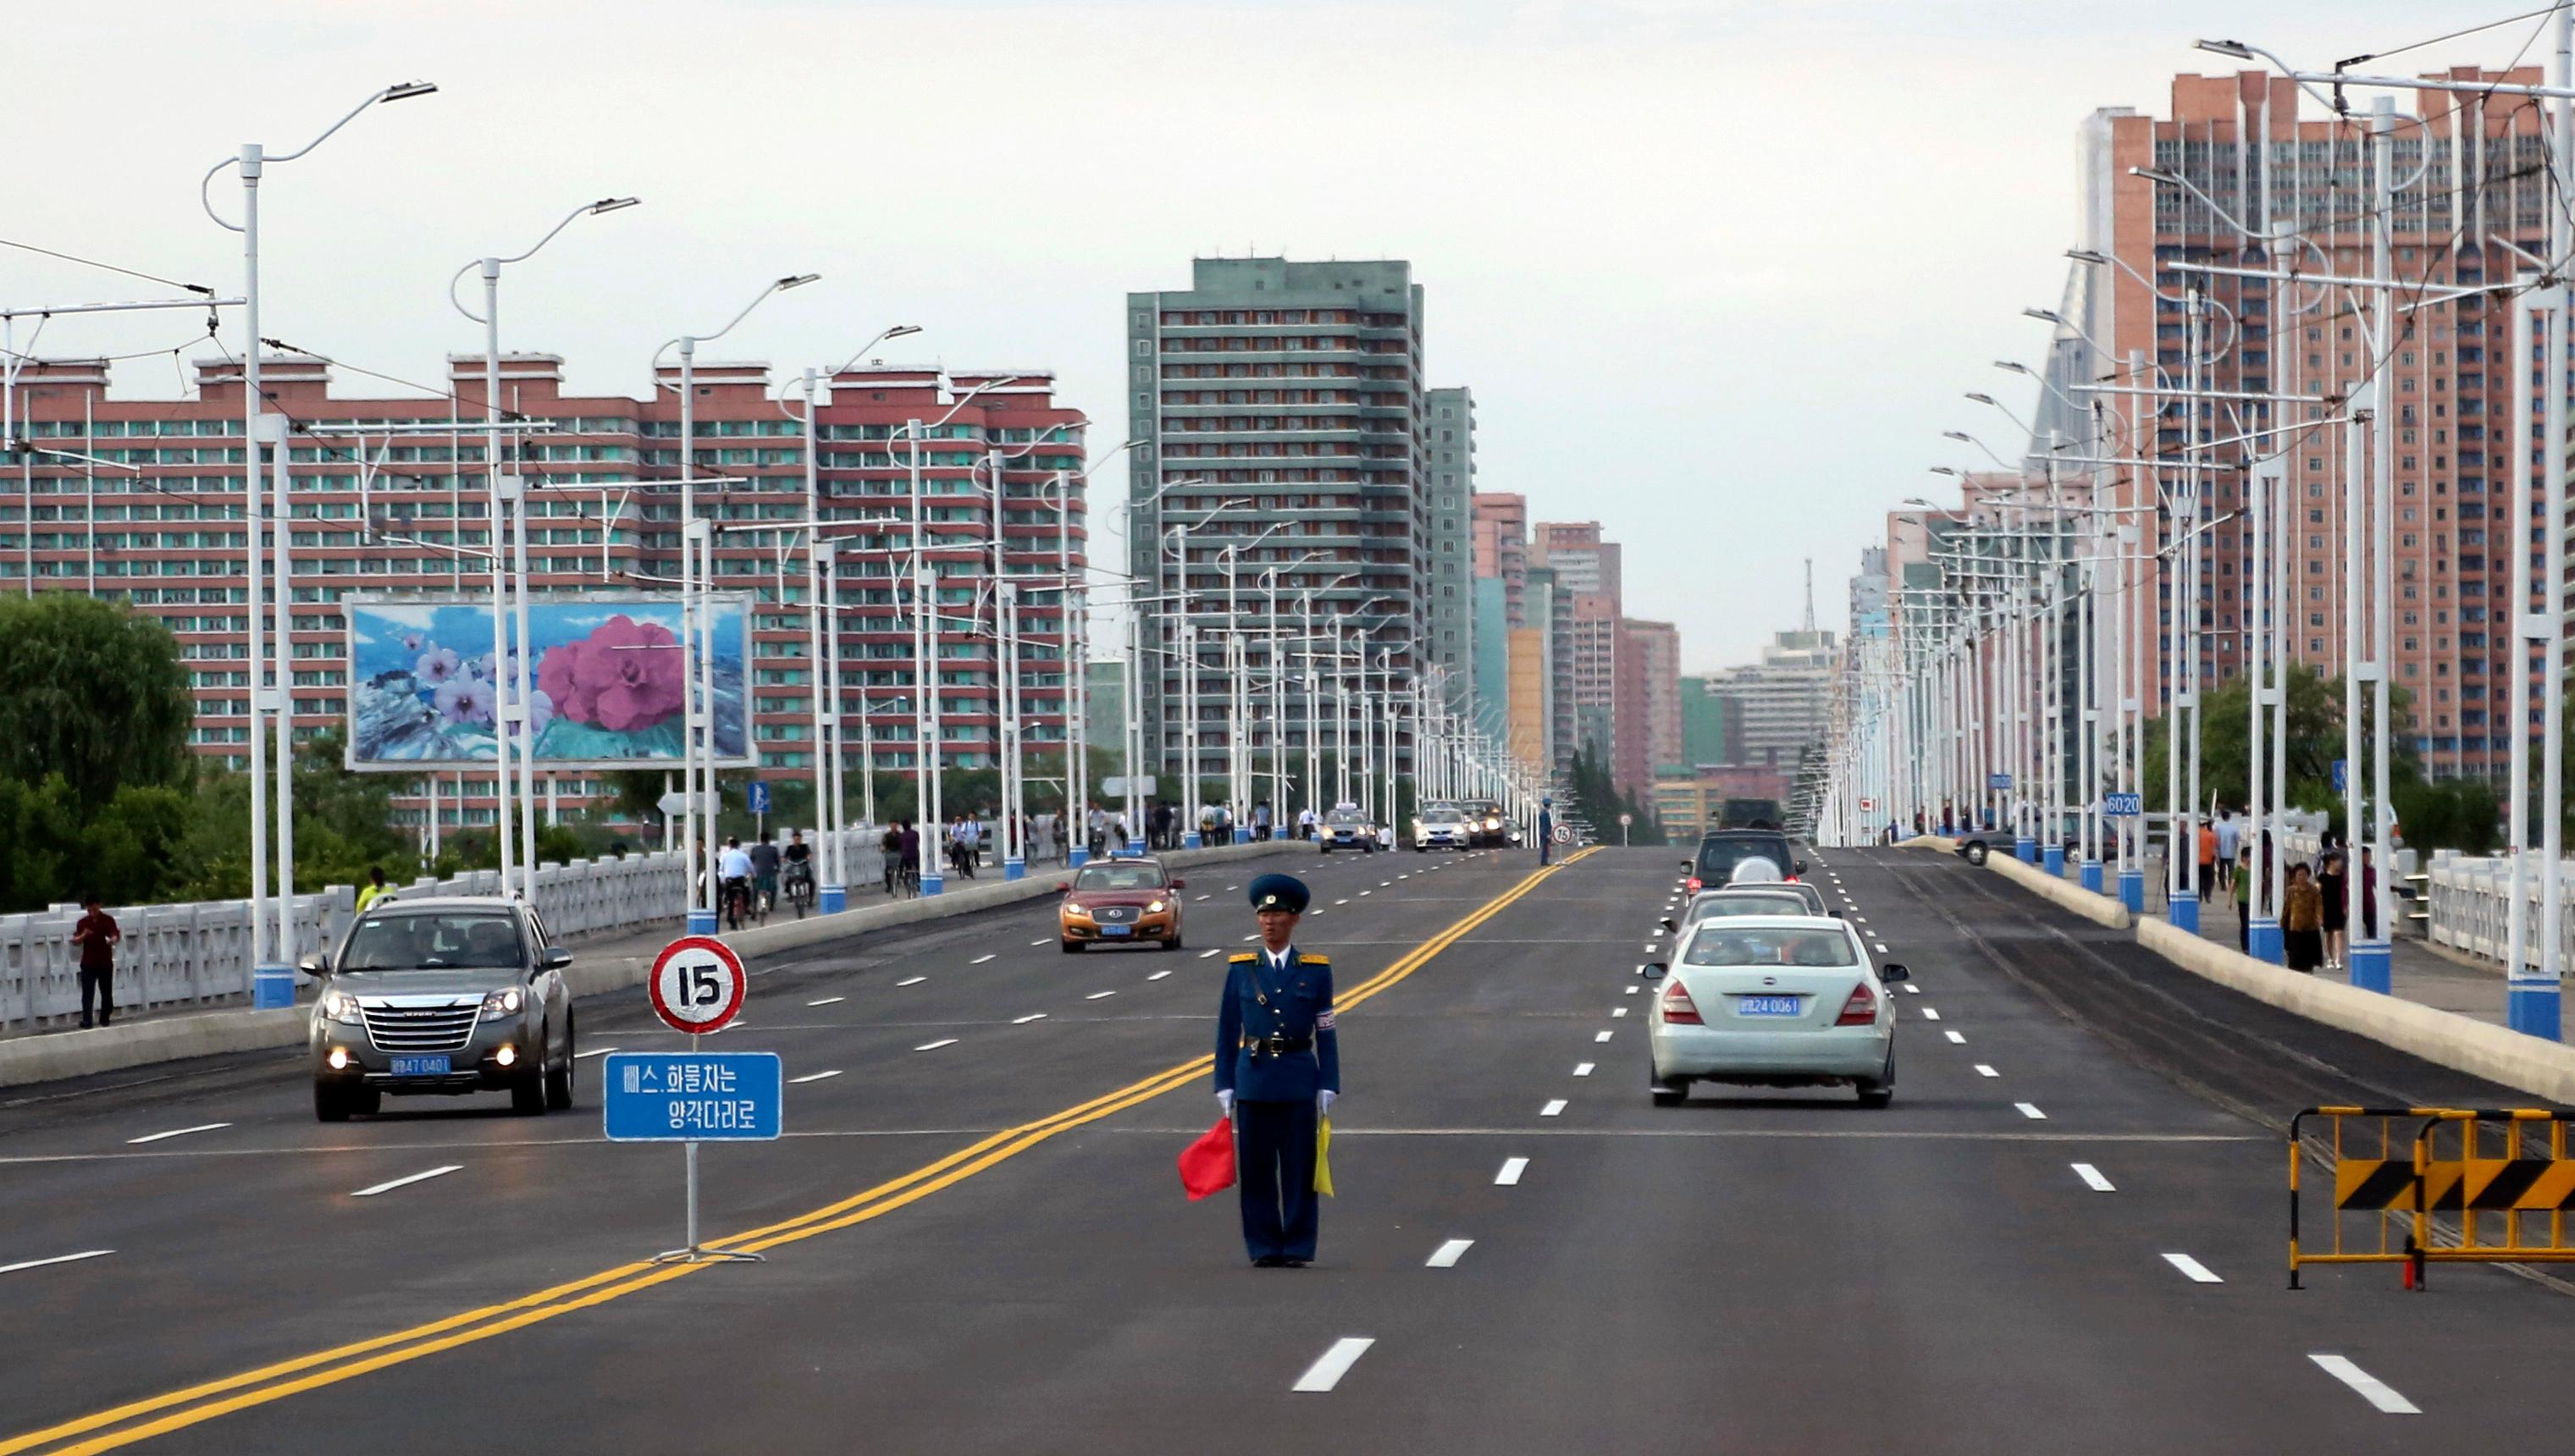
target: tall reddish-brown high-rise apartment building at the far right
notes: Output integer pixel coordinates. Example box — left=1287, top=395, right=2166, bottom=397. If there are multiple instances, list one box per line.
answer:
left=2042, top=67, right=2550, bottom=777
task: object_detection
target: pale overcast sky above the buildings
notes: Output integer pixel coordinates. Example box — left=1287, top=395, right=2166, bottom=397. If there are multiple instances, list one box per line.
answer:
left=0, top=0, right=2547, bottom=671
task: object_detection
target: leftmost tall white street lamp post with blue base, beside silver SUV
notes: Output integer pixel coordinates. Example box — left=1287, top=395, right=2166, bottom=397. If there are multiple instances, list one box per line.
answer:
left=201, top=80, right=438, bottom=1008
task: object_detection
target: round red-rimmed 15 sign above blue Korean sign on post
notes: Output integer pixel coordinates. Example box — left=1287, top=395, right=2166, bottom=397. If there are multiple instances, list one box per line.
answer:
left=600, top=936, right=786, bottom=1263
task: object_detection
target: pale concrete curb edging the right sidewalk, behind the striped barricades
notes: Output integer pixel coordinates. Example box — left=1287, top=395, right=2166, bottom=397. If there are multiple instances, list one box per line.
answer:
left=2137, top=918, right=2575, bottom=1106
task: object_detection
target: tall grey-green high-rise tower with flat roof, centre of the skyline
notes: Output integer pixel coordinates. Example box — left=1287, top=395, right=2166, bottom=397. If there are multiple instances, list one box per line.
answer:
left=1128, top=257, right=1431, bottom=775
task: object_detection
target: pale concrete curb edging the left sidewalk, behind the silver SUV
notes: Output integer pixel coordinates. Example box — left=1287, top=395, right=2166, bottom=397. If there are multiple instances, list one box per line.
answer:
left=0, top=841, right=1313, bottom=1088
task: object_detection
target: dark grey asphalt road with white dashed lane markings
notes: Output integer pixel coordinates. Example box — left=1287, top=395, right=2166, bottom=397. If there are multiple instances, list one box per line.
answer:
left=0, top=849, right=2575, bottom=1456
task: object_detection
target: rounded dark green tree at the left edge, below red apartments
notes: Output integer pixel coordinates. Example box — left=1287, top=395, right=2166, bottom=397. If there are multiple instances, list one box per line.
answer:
left=0, top=592, right=196, bottom=810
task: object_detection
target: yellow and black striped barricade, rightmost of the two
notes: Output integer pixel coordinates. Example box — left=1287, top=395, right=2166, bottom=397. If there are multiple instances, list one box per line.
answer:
left=2407, top=1106, right=2575, bottom=1288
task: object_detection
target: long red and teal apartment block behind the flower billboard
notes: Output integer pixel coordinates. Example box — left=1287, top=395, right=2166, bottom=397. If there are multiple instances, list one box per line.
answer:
left=0, top=355, right=1086, bottom=825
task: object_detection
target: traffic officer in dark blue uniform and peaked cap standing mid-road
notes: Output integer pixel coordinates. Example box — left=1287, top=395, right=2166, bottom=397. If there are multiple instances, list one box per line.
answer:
left=1215, top=874, right=1341, bottom=1268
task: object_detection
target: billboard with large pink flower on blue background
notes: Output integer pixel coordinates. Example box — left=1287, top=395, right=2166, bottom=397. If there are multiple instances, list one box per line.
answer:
left=342, top=592, right=752, bottom=772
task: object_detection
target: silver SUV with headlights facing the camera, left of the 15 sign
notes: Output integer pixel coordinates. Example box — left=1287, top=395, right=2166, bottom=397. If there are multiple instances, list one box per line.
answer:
left=301, top=898, right=574, bottom=1122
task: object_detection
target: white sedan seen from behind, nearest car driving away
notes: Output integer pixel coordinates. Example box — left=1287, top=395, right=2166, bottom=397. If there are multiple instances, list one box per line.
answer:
left=1640, top=916, right=1905, bottom=1106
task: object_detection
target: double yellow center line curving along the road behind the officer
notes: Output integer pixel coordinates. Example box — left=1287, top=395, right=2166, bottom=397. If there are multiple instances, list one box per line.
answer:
left=0, top=847, right=1596, bottom=1456
